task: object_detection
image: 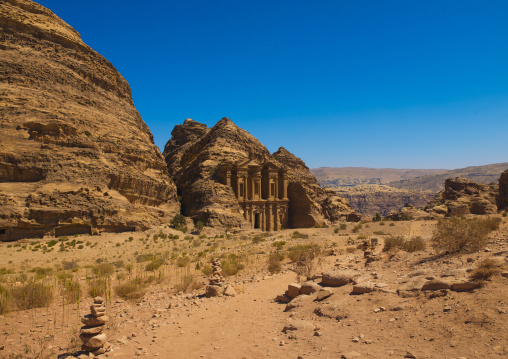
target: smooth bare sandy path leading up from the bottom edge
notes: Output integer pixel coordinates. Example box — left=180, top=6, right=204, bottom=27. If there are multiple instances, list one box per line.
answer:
left=112, top=272, right=308, bottom=359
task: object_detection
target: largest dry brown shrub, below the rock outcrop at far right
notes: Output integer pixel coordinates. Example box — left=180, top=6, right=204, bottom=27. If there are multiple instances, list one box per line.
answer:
left=432, top=218, right=501, bottom=253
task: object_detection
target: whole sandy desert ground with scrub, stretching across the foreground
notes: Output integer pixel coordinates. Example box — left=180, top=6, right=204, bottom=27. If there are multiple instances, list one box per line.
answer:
left=0, top=216, right=508, bottom=359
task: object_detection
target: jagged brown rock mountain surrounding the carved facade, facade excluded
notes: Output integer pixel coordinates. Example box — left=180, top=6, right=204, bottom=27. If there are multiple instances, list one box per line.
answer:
left=163, top=118, right=353, bottom=227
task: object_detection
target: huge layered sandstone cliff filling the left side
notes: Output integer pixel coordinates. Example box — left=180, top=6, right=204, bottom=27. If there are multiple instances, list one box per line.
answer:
left=0, top=0, right=179, bottom=240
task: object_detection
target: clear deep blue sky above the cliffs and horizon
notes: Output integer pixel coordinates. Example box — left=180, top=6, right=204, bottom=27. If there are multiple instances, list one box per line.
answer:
left=40, top=0, right=508, bottom=169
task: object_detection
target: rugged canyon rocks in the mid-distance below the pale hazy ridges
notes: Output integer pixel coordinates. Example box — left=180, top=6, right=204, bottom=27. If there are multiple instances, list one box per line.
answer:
left=334, top=185, right=436, bottom=217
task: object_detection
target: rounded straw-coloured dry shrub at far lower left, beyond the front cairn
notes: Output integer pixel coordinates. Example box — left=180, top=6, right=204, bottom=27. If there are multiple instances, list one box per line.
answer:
left=12, top=282, right=53, bottom=310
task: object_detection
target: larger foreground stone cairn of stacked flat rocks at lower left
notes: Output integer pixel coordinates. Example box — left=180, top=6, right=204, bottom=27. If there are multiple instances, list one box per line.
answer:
left=79, top=297, right=110, bottom=355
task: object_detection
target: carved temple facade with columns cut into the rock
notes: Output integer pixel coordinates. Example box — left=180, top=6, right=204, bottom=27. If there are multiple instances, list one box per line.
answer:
left=217, top=160, right=289, bottom=231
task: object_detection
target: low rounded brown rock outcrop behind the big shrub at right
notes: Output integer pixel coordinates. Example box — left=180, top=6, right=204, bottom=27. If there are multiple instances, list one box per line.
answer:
left=425, top=177, right=498, bottom=216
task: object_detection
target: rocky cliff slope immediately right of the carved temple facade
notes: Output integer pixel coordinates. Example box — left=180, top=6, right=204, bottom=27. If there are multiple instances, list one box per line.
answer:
left=273, top=147, right=354, bottom=228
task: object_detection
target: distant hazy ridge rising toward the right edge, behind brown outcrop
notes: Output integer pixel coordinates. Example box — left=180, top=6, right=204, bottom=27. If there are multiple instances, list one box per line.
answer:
left=388, top=162, right=508, bottom=192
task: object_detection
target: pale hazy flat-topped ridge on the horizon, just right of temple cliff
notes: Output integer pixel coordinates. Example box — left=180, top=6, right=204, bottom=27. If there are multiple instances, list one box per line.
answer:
left=311, top=167, right=447, bottom=187
